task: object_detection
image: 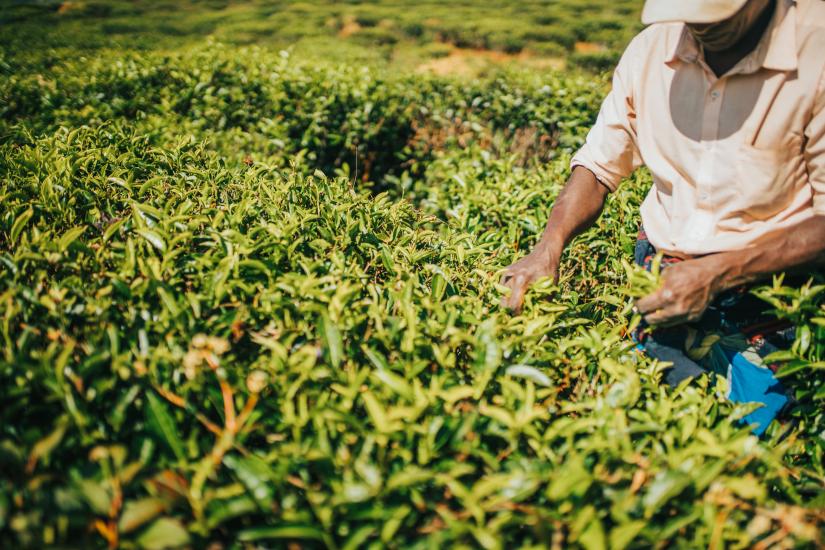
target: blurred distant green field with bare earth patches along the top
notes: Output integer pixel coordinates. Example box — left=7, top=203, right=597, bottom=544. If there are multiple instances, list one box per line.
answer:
left=0, top=0, right=640, bottom=69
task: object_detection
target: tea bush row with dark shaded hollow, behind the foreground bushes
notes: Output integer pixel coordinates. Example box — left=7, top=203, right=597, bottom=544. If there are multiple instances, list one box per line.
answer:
left=0, top=45, right=604, bottom=183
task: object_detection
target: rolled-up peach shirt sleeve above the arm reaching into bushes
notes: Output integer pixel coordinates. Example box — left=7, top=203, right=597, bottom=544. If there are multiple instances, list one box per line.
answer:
left=570, top=36, right=644, bottom=191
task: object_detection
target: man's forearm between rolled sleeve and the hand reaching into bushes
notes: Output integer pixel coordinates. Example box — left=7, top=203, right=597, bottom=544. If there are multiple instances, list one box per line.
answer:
left=536, top=166, right=608, bottom=257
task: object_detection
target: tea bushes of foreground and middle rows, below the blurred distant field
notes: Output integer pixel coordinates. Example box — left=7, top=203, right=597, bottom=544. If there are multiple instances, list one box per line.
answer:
left=0, top=8, right=825, bottom=549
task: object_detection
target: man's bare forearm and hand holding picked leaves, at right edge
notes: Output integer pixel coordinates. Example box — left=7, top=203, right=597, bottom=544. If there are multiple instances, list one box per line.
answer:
left=636, top=216, right=825, bottom=326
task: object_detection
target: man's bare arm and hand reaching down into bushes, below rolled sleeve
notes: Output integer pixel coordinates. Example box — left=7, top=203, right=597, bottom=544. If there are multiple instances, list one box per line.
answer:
left=502, top=166, right=609, bottom=312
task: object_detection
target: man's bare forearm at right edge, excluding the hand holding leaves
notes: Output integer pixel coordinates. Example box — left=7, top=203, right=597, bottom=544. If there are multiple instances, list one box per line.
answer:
left=700, top=216, right=825, bottom=291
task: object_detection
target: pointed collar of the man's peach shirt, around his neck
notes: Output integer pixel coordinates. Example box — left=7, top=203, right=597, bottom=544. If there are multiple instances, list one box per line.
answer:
left=666, top=0, right=799, bottom=73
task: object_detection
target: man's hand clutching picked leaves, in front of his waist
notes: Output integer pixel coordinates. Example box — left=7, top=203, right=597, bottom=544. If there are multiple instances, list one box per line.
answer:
left=636, top=257, right=720, bottom=326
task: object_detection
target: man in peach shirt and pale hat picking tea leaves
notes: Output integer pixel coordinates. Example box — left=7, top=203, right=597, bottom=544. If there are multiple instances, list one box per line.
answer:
left=504, top=0, right=825, bottom=433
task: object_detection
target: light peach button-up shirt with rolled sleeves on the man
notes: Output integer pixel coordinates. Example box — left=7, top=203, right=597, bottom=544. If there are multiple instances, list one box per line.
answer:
left=571, top=0, right=825, bottom=256
